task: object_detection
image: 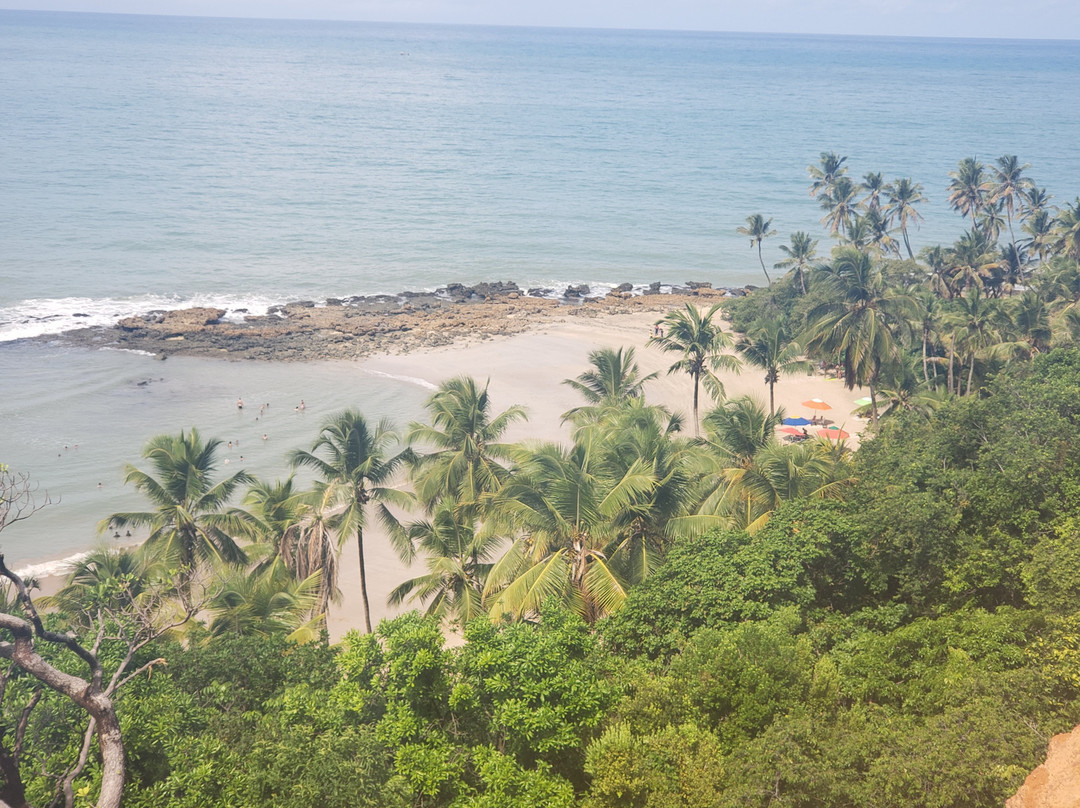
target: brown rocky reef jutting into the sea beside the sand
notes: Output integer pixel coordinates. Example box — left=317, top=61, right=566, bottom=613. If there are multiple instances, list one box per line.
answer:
left=29, top=282, right=750, bottom=362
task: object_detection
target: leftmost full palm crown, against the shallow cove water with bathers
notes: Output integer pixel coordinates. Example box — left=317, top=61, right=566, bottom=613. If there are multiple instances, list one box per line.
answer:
left=104, top=428, right=254, bottom=581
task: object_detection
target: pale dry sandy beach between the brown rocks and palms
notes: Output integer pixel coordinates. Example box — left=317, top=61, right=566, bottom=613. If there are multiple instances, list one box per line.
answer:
left=16, top=291, right=863, bottom=642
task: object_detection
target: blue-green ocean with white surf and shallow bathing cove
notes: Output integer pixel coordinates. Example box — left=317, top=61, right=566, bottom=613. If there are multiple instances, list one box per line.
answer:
left=0, top=11, right=1080, bottom=571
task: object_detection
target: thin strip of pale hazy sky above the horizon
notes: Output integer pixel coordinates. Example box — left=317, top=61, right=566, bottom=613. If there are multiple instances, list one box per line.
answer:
left=0, top=0, right=1080, bottom=39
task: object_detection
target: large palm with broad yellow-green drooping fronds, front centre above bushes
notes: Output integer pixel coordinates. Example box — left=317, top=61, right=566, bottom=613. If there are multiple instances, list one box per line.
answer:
left=484, top=436, right=656, bottom=622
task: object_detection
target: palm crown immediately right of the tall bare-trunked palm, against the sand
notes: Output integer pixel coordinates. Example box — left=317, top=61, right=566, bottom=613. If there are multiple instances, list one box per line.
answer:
left=405, top=376, right=526, bottom=513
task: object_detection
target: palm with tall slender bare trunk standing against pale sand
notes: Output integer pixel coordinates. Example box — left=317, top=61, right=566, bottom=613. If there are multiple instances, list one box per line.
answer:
left=289, top=409, right=413, bottom=634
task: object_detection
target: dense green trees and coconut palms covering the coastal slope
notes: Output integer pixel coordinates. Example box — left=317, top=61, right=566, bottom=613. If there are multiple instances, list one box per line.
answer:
left=0, top=154, right=1080, bottom=808
